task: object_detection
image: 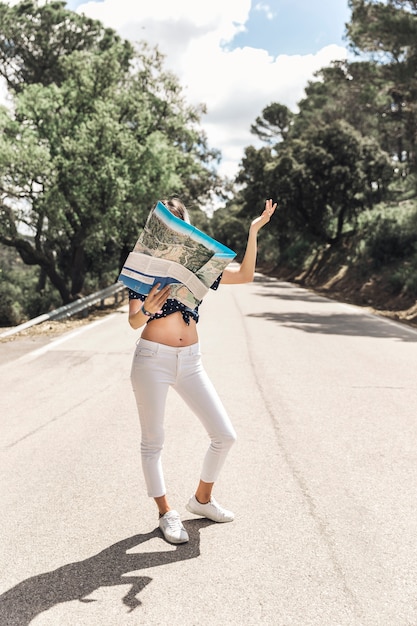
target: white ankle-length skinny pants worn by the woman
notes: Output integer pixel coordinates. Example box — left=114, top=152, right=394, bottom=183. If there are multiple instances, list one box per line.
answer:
left=131, top=339, right=236, bottom=498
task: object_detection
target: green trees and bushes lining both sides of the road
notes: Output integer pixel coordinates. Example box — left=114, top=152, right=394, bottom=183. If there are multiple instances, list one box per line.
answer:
left=0, top=0, right=417, bottom=325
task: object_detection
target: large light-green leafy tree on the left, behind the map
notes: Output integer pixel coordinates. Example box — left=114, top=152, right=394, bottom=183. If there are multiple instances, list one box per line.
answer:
left=0, top=3, right=223, bottom=302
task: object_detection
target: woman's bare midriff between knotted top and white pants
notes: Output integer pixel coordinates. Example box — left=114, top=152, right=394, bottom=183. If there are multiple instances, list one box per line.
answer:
left=141, top=311, right=198, bottom=348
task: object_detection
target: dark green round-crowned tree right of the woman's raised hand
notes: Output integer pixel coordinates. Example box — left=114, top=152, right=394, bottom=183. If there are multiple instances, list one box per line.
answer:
left=274, top=121, right=392, bottom=245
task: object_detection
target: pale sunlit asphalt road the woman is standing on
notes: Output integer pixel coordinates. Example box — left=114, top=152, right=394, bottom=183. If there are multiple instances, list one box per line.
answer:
left=0, top=276, right=417, bottom=626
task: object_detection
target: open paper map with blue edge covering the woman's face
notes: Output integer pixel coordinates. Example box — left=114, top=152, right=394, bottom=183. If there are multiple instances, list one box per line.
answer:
left=119, top=202, right=236, bottom=309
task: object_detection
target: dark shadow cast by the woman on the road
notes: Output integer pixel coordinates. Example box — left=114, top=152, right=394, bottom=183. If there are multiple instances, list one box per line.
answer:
left=0, top=519, right=214, bottom=626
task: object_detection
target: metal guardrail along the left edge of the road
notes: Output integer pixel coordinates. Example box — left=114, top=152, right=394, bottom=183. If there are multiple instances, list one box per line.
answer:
left=0, top=283, right=125, bottom=339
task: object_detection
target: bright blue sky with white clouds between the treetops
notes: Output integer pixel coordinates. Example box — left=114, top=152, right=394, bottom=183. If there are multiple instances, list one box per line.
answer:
left=7, top=0, right=350, bottom=178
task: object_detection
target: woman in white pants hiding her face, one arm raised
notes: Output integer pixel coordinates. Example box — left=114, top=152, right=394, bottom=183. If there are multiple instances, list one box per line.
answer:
left=129, top=198, right=276, bottom=544
